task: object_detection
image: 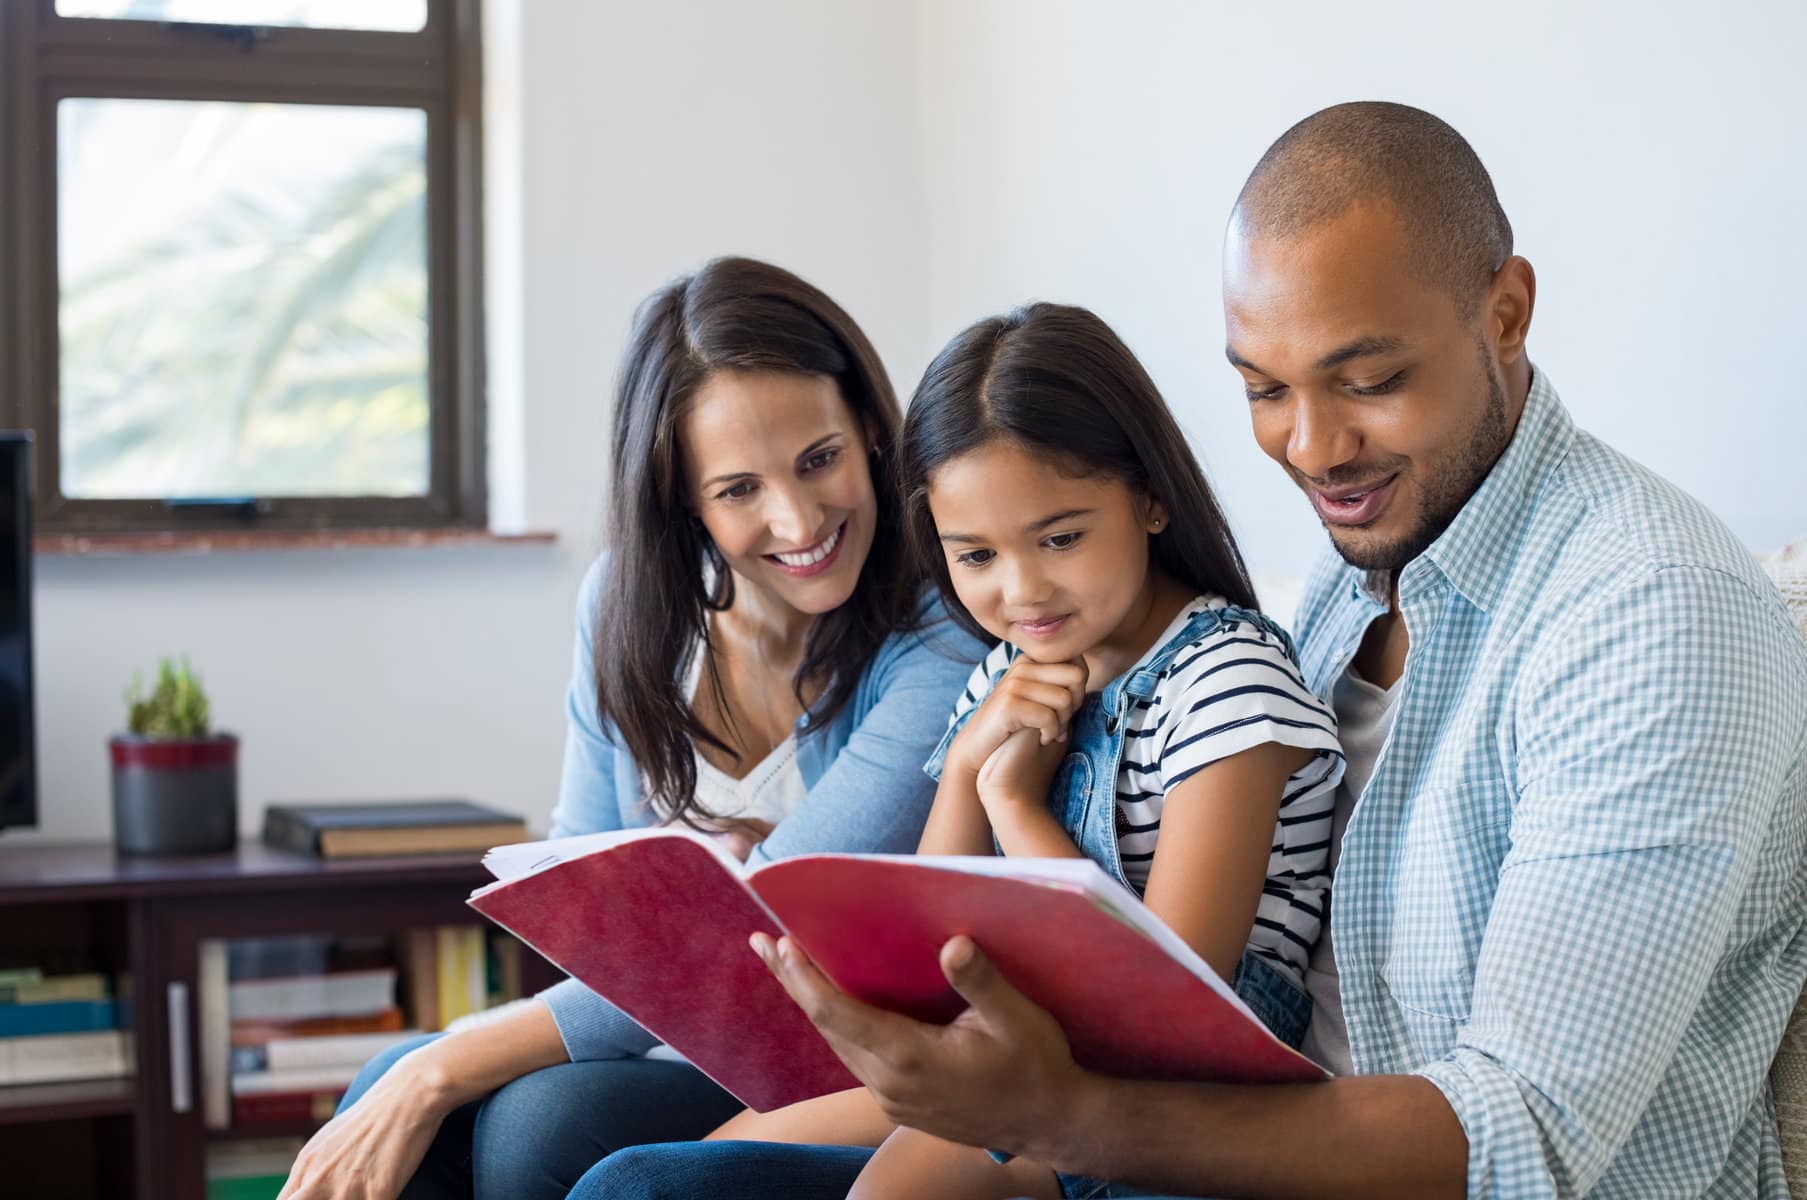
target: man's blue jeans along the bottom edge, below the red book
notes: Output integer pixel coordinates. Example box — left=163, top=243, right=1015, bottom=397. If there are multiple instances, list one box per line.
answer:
left=571, top=1142, right=1207, bottom=1200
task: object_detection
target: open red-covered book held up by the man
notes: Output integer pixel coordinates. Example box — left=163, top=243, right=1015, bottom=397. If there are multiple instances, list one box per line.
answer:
left=470, top=830, right=1326, bottom=1111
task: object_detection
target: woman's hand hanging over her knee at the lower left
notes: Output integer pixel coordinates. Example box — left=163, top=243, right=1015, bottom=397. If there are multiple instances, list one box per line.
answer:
left=276, top=1045, right=455, bottom=1200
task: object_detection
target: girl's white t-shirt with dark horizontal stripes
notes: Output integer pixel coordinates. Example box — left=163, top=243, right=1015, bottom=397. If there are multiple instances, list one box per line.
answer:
left=952, top=596, right=1343, bottom=983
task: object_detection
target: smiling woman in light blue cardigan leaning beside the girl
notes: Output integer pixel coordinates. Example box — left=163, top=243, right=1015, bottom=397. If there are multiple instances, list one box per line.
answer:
left=282, top=258, right=985, bottom=1200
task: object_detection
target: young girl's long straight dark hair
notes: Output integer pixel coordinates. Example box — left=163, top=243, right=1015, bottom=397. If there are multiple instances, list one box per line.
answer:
left=900, top=304, right=1256, bottom=640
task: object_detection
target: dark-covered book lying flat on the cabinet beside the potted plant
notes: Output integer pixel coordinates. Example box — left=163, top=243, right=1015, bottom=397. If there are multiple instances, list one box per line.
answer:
left=264, top=801, right=528, bottom=858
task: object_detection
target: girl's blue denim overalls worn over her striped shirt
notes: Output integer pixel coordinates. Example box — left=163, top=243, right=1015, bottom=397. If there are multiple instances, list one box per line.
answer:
left=923, top=605, right=1312, bottom=1048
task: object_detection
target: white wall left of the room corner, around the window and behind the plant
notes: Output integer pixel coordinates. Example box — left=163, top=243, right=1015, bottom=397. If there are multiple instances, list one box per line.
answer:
left=21, top=0, right=927, bottom=844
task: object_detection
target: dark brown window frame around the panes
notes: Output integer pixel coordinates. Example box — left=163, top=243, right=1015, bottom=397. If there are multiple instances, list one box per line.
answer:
left=0, top=0, right=488, bottom=533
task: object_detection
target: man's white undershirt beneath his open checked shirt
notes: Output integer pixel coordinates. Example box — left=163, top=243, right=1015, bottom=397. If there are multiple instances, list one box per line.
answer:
left=1301, top=665, right=1399, bottom=1075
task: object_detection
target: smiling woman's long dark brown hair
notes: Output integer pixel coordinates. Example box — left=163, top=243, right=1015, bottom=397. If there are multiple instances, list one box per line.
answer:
left=595, top=258, right=923, bottom=824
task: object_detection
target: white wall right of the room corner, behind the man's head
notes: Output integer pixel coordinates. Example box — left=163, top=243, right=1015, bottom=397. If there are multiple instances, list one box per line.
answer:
left=918, top=0, right=1807, bottom=573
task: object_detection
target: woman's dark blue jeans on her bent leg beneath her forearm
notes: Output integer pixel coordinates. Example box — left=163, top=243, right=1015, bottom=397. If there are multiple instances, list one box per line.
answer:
left=340, top=1034, right=740, bottom=1200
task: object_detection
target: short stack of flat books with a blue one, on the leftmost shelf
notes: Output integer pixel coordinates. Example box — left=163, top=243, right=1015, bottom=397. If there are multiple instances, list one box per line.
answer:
left=0, top=967, right=132, bottom=1086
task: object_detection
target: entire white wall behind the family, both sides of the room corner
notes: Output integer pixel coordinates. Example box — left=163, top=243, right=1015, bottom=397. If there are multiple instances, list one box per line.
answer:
left=21, top=0, right=1807, bottom=842
